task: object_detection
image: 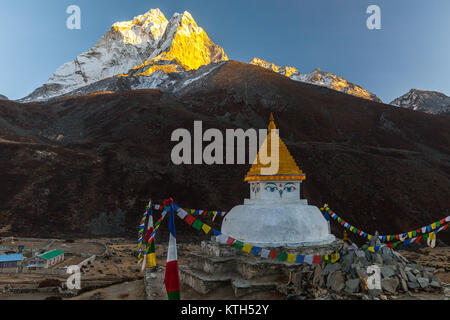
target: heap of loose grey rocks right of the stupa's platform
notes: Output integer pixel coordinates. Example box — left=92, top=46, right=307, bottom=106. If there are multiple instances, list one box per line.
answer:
left=296, top=244, right=443, bottom=300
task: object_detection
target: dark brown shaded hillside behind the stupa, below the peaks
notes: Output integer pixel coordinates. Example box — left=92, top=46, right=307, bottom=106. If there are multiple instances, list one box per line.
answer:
left=0, top=61, right=450, bottom=245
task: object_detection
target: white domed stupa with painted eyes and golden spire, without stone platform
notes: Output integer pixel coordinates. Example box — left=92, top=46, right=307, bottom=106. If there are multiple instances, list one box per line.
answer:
left=222, top=114, right=335, bottom=248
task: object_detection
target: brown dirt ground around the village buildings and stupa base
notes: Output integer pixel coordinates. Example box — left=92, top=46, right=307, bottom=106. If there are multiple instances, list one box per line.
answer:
left=0, top=238, right=450, bottom=300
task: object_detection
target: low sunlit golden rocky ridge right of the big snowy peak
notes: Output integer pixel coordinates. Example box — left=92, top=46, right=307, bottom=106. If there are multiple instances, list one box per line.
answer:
left=250, top=58, right=382, bottom=102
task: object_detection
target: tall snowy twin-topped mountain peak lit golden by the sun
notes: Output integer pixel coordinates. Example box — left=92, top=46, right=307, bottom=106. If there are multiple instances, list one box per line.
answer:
left=21, top=9, right=228, bottom=102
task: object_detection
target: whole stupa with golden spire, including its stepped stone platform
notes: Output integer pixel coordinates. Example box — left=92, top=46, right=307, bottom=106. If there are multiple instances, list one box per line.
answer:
left=180, top=115, right=344, bottom=298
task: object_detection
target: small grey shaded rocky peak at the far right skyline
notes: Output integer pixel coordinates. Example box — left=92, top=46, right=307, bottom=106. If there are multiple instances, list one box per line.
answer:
left=391, top=89, right=450, bottom=114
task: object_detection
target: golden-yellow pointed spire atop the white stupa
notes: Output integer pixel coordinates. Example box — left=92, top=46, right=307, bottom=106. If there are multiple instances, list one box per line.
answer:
left=244, top=114, right=306, bottom=181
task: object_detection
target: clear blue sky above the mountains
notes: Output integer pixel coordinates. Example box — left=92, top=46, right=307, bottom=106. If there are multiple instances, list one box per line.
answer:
left=0, top=0, right=450, bottom=102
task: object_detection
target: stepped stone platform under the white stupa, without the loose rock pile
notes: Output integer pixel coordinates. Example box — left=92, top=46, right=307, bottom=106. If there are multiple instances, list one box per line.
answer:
left=179, top=237, right=344, bottom=298
